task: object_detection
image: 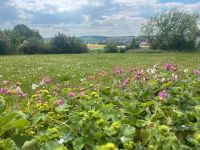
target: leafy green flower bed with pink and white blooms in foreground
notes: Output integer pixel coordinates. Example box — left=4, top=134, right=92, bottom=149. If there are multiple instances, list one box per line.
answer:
left=0, top=64, right=200, bottom=150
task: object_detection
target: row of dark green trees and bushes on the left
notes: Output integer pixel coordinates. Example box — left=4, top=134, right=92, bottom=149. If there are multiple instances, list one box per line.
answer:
left=0, top=24, right=88, bottom=55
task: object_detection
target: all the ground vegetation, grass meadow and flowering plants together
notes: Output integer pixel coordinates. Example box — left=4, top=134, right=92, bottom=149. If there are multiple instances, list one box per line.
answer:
left=0, top=53, right=200, bottom=150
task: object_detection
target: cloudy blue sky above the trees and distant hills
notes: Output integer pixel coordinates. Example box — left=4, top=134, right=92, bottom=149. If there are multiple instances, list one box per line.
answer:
left=0, top=0, right=200, bottom=37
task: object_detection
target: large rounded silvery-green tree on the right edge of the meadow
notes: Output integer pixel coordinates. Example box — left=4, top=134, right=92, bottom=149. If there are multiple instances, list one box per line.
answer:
left=142, top=10, right=199, bottom=50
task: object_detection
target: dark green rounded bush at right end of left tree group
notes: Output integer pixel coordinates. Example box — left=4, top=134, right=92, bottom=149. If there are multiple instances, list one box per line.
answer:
left=51, top=33, right=88, bottom=54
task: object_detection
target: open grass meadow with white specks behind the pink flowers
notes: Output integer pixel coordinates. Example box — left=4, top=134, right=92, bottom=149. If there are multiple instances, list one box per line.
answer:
left=0, top=53, right=200, bottom=86
